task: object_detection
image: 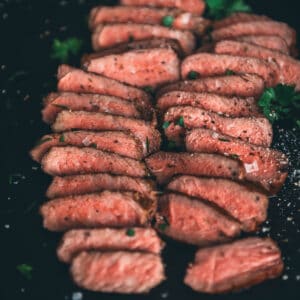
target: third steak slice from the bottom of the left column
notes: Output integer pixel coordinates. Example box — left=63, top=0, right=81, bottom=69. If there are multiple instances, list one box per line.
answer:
left=40, top=191, right=156, bottom=231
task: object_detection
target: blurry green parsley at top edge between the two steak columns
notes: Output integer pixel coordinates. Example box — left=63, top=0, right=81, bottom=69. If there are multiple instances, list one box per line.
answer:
left=205, top=0, right=252, bottom=19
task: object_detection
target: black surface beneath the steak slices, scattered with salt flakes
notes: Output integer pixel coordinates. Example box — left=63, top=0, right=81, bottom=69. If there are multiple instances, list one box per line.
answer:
left=0, top=0, right=300, bottom=300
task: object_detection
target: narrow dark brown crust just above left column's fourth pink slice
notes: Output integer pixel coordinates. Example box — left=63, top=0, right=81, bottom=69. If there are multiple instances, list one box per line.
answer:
left=81, top=38, right=183, bottom=66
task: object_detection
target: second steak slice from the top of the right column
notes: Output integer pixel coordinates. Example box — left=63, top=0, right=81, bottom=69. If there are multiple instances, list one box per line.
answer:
left=210, top=21, right=296, bottom=48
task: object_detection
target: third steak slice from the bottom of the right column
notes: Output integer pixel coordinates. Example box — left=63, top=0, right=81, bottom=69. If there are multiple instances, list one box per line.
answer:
left=167, top=176, right=268, bottom=232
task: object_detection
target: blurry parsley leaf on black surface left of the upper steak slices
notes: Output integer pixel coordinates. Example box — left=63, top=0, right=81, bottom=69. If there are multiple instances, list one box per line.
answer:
left=51, top=38, right=82, bottom=63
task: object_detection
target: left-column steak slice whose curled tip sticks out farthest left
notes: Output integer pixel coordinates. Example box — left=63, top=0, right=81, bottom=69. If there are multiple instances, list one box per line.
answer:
left=30, top=131, right=144, bottom=162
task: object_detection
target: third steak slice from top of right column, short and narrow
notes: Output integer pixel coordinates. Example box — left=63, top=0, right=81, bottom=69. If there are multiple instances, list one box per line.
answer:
left=235, top=35, right=290, bottom=55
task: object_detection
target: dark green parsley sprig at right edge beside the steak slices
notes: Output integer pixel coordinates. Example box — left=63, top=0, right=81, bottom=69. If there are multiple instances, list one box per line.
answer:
left=258, top=84, right=300, bottom=127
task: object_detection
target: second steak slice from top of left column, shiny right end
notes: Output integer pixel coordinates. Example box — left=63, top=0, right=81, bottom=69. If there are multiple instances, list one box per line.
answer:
left=89, top=6, right=210, bottom=34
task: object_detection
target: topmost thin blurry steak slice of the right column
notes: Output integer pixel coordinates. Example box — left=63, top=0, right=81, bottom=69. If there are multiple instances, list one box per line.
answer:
left=213, top=12, right=271, bottom=29
